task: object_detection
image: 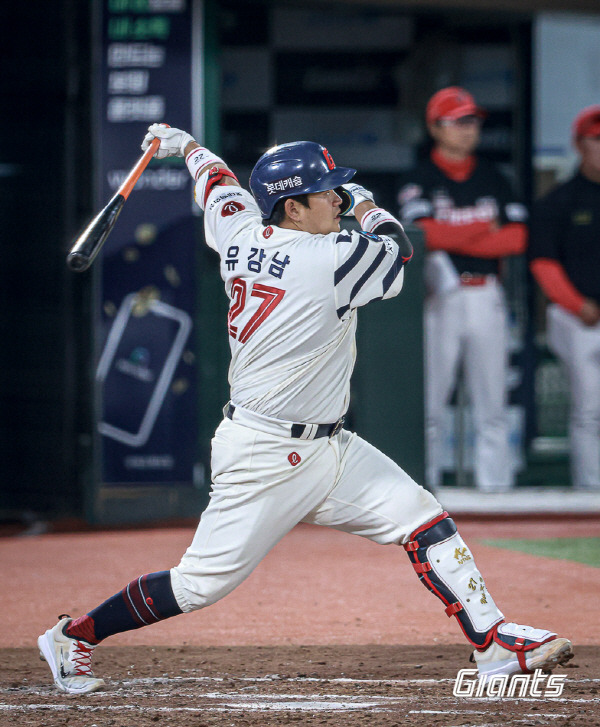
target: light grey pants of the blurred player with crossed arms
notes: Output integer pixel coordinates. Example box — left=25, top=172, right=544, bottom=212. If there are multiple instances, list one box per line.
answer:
left=425, top=276, right=514, bottom=491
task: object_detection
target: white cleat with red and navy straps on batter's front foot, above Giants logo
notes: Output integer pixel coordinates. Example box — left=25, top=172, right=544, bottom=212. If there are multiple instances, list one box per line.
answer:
left=473, top=623, right=573, bottom=676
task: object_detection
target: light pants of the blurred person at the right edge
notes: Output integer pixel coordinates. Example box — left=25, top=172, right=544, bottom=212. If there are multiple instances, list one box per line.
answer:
left=547, top=304, right=600, bottom=490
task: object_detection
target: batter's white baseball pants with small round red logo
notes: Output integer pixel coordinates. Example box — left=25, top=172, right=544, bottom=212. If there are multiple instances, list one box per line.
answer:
left=171, top=419, right=442, bottom=612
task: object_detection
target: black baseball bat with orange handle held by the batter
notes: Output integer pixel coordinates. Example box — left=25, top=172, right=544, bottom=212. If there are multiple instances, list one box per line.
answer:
left=67, top=138, right=160, bottom=273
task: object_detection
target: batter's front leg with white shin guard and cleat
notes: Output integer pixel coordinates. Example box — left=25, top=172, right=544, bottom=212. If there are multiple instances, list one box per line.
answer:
left=305, top=432, right=572, bottom=674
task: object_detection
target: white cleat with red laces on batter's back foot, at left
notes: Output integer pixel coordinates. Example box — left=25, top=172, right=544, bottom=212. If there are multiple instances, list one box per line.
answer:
left=38, top=616, right=104, bottom=694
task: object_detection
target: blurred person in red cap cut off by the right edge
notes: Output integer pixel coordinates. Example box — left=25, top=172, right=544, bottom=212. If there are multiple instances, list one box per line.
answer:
left=530, top=105, right=600, bottom=491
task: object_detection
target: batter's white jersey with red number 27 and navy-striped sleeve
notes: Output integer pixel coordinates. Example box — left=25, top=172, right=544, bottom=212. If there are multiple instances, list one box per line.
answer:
left=196, top=183, right=404, bottom=423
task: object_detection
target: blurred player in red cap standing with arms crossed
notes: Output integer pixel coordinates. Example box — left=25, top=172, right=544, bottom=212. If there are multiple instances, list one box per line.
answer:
left=399, top=86, right=527, bottom=492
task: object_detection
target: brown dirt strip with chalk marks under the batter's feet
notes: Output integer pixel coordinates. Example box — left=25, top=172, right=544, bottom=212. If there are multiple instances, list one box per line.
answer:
left=0, top=645, right=600, bottom=727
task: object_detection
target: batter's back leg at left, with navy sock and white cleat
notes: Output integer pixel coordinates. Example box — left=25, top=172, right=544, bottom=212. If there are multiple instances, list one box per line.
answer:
left=38, top=418, right=337, bottom=693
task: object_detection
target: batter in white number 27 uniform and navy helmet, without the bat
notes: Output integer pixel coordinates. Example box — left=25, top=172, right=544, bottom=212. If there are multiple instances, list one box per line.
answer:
left=38, top=124, right=572, bottom=693
